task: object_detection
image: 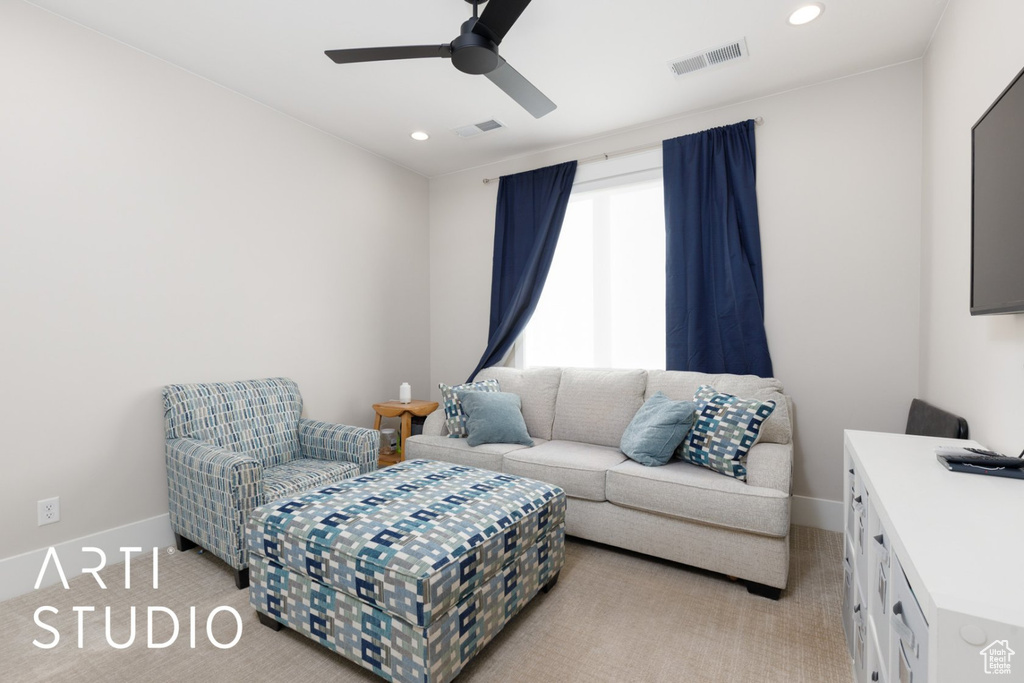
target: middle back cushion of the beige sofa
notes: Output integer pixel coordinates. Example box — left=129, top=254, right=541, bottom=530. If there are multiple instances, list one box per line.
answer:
left=551, top=368, right=643, bottom=448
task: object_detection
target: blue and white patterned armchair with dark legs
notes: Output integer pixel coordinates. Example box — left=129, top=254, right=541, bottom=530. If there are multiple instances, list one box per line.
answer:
left=164, top=378, right=380, bottom=589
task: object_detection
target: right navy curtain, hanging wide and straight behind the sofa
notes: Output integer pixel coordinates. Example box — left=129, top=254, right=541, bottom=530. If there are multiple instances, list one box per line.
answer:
left=662, top=121, right=772, bottom=377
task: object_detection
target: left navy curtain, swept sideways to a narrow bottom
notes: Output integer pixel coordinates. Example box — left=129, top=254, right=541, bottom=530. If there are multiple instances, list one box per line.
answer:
left=467, top=161, right=577, bottom=382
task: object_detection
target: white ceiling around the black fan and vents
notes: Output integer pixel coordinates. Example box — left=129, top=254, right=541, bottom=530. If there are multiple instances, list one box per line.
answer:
left=25, top=0, right=947, bottom=176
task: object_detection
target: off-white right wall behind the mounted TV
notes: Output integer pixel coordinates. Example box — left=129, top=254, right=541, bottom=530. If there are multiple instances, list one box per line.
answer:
left=921, top=0, right=1024, bottom=455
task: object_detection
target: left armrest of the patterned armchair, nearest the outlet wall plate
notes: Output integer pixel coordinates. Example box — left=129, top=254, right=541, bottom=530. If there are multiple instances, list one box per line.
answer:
left=166, top=438, right=265, bottom=569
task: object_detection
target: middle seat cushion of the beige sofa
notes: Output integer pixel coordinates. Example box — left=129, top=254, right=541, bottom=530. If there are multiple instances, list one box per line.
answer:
left=503, top=441, right=626, bottom=501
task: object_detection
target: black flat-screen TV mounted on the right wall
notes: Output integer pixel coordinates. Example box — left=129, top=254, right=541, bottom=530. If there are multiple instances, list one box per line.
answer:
left=971, top=63, right=1024, bottom=315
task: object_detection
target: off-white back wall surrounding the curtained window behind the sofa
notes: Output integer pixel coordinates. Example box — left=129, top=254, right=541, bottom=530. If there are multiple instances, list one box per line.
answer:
left=430, top=61, right=922, bottom=501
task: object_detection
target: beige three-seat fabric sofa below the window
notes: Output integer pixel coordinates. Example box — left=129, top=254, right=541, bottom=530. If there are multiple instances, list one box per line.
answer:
left=406, top=368, right=793, bottom=598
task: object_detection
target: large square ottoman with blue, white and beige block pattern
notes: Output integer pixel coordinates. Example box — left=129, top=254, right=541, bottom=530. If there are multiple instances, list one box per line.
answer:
left=246, top=460, right=565, bottom=683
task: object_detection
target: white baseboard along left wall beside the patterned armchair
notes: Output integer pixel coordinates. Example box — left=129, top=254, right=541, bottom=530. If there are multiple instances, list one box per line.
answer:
left=0, top=514, right=174, bottom=602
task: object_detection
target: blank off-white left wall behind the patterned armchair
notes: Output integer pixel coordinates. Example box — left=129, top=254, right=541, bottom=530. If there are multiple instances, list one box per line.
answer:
left=0, top=2, right=429, bottom=557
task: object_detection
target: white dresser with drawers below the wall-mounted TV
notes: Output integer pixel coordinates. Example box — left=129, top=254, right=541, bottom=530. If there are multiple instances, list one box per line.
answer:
left=843, top=431, right=1024, bottom=683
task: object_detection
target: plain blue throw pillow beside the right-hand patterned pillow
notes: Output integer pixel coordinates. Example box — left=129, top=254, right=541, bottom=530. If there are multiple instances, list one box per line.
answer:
left=618, top=391, right=697, bottom=467
